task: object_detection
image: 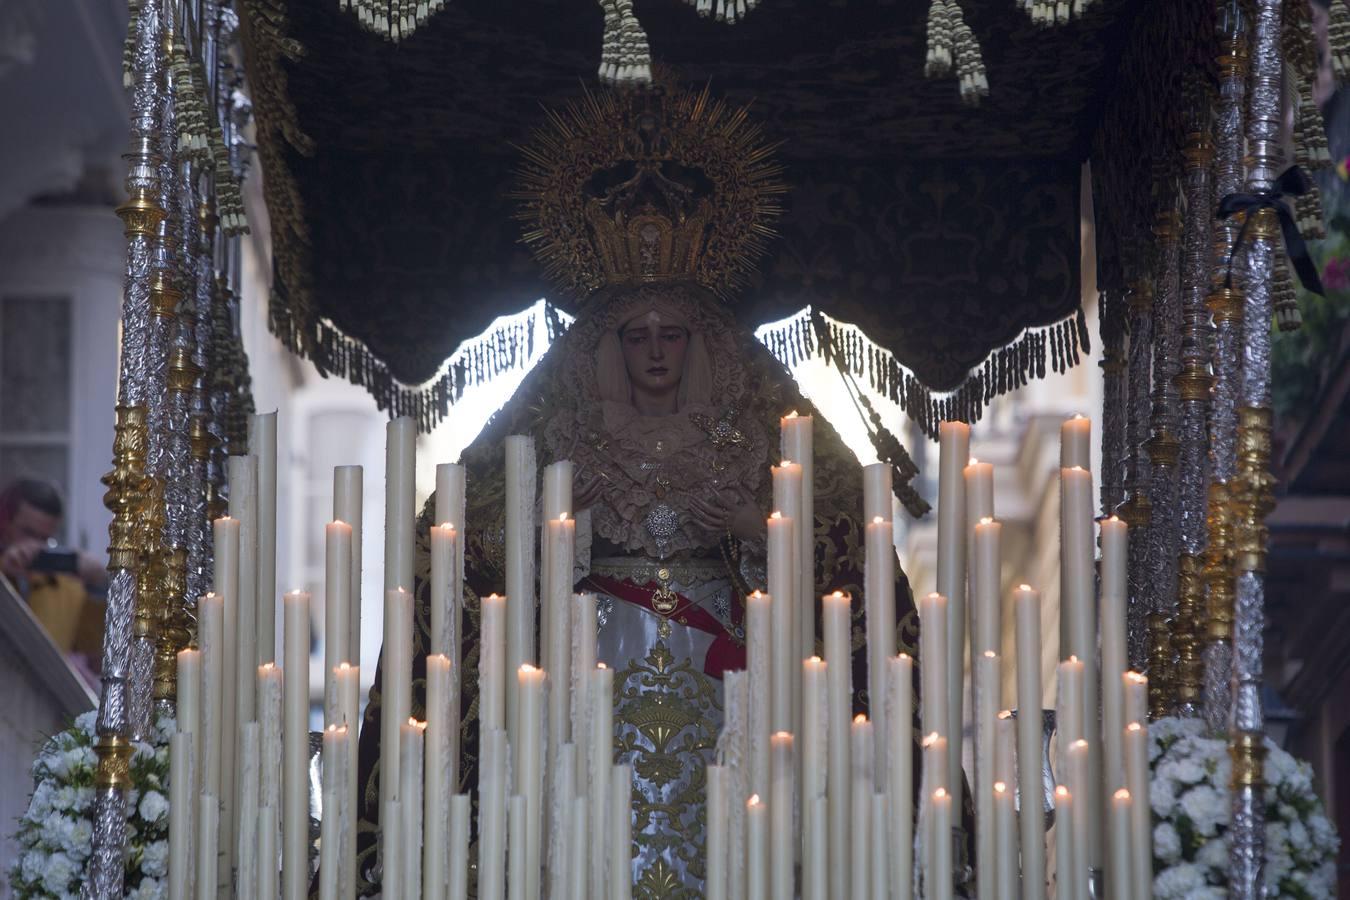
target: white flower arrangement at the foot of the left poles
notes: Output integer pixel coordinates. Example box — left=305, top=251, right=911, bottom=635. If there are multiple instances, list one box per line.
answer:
left=9, top=712, right=174, bottom=900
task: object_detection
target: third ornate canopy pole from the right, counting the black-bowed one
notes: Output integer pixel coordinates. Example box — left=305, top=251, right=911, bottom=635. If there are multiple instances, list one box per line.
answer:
left=1172, top=112, right=1214, bottom=716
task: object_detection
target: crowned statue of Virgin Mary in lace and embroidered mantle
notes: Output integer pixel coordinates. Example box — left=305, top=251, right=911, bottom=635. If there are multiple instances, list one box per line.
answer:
left=360, top=80, right=934, bottom=897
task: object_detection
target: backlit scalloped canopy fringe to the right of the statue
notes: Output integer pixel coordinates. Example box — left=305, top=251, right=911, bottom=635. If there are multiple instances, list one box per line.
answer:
left=756, top=308, right=1091, bottom=440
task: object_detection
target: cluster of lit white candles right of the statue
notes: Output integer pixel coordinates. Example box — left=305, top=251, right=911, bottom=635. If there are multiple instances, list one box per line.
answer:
left=706, top=417, right=1152, bottom=900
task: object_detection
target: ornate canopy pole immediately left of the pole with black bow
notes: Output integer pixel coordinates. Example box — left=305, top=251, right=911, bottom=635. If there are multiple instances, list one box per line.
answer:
left=1204, top=19, right=1247, bottom=734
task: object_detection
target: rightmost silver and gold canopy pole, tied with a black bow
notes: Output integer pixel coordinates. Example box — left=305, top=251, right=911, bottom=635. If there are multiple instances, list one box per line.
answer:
left=1229, top=0, right=1281, bottom=900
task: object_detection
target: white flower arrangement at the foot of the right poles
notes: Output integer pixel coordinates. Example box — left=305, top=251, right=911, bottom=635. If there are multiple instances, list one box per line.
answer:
left=1149, top=718, right=1341, bottom=900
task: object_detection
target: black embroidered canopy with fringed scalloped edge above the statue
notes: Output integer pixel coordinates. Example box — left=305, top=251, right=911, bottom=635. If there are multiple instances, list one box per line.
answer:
left=244, top=0, right=1206, bottom=426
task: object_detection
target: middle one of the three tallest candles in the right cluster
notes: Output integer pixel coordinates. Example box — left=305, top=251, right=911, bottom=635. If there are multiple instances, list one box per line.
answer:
left=919, top=422, right=971, bottom=806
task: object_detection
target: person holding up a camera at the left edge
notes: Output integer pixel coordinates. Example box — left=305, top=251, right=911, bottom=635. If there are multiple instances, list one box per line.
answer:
left=0, top=478, right=108, bottom=661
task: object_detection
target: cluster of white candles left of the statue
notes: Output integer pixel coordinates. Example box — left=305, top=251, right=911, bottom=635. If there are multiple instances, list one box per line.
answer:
left=160, top=417, right=632, bottom=900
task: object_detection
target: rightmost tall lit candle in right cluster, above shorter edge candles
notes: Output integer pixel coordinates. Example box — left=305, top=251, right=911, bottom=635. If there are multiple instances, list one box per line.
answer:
left=1102, top=515, right=1129, bottom=792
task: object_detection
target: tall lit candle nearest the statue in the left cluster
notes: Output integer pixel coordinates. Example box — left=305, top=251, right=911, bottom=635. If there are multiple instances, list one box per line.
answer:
left=540, top=518, right=576, bottom=757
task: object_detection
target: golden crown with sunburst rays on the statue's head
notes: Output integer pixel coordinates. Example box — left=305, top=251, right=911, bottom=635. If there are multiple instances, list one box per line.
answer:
left=514, top=85, right=784, bottom=300
